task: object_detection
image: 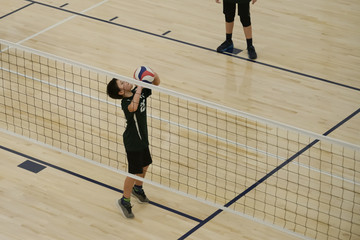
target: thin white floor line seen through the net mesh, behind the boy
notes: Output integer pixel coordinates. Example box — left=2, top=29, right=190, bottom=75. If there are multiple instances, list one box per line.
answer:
left=0, top=67, right=360, bottom=186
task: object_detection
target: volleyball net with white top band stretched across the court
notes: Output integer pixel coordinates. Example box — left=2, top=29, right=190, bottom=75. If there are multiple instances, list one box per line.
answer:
left=0, top=40, right=360, bottom=239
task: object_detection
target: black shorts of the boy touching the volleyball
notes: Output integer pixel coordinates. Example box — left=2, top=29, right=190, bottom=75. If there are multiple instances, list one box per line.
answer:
left=126, top=147, right=152, bottom=174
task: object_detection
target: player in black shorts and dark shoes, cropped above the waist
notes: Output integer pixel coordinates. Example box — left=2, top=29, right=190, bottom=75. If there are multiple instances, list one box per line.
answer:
left=216, top=0, right=257, bottom=59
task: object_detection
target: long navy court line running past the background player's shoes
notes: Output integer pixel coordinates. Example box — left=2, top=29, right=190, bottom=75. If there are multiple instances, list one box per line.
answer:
left=9, top=0, right=360, bottom=91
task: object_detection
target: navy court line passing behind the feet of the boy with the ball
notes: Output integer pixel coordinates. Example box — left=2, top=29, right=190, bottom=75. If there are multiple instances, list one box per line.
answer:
left=0, top=142, right=202, bottom=222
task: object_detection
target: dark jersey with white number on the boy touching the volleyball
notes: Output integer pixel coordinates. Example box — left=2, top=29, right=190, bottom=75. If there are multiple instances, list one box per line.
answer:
left=121, top=88, right=151, bottom=151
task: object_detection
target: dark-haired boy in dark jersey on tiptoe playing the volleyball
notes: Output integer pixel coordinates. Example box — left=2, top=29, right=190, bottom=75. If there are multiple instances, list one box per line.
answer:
left=107, top=70, right=160, bottom=218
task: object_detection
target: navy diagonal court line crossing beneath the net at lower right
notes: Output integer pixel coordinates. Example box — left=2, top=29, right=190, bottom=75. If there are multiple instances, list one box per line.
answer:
left=178, top=108, right=360, bottom=240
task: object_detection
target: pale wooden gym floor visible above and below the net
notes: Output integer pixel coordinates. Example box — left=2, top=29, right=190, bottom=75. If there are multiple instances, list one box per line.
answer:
left=0, top=0, right=360, bottom=239
